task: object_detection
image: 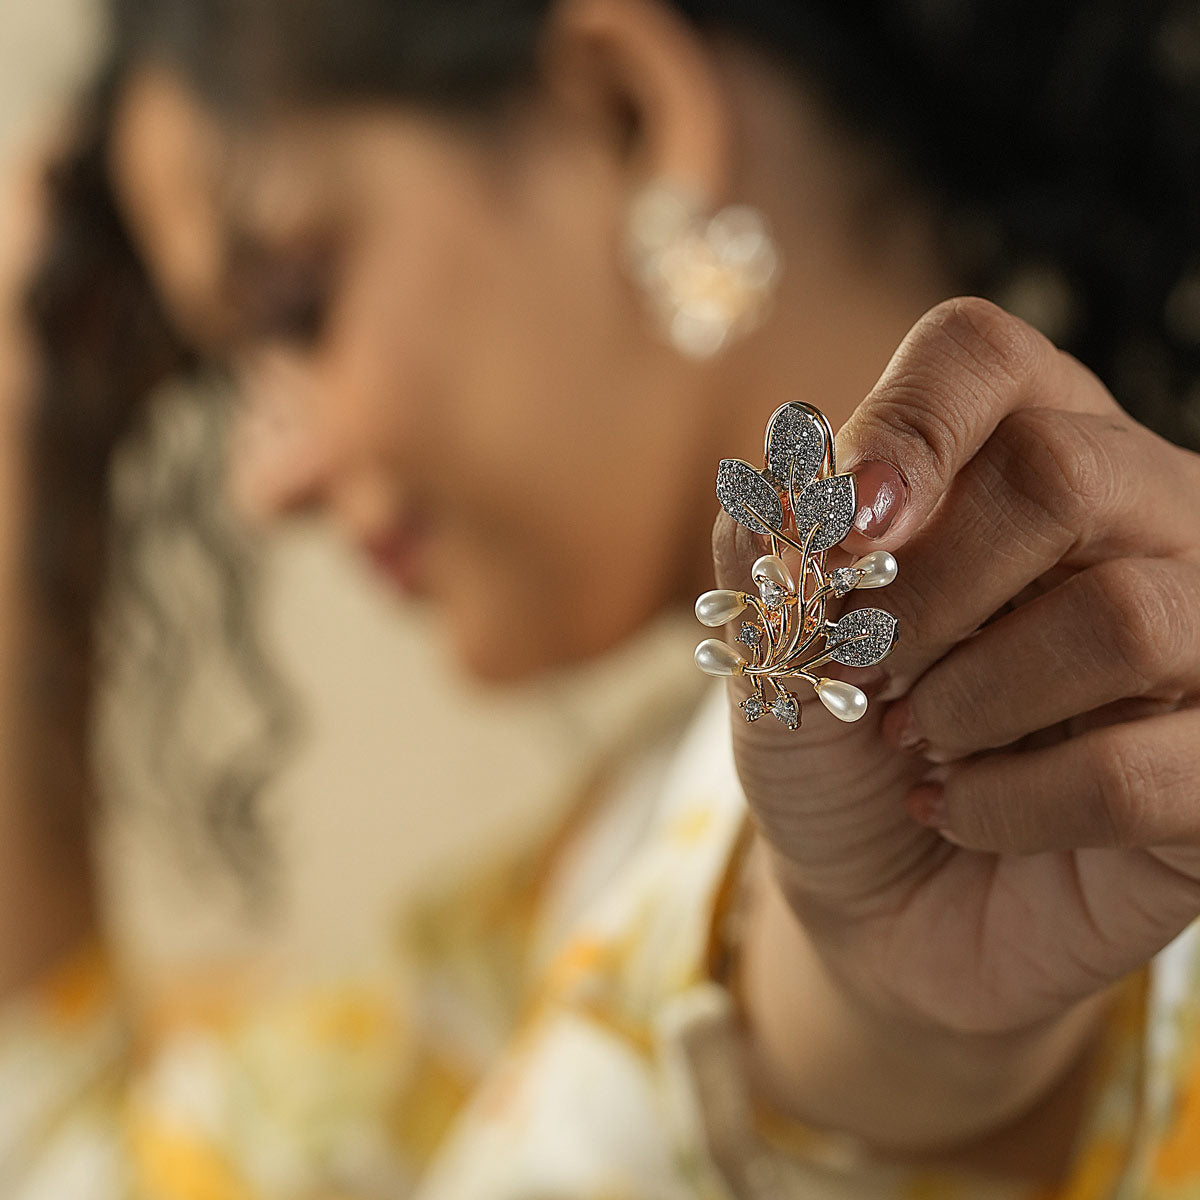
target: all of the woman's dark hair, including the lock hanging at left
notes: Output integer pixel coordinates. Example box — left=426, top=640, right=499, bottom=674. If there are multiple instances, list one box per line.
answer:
left=23, top=0, right=1200, bottom=883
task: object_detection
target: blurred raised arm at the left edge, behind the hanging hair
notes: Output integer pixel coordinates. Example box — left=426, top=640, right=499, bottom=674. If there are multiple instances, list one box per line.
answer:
left=0, top=148, right=95, bottom=997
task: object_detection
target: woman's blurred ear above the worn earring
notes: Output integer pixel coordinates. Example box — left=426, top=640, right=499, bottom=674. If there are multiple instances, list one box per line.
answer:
left=541, top=0, right=732, bottom=206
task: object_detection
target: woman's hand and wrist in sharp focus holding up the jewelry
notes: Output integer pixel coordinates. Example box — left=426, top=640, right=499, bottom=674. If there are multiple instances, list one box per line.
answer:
left=714, top=299, right=1200, bottom=1176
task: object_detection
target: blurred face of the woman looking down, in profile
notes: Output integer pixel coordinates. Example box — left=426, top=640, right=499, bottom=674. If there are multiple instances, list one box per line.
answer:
left=114, top=74, right=729, bottom=678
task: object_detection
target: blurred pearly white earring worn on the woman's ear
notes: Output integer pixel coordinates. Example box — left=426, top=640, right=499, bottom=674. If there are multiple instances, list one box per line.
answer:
left=626, top=180, right=780, bottom=359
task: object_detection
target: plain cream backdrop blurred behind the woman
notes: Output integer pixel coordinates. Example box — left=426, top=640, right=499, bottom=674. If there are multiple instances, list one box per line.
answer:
left=0, top=0, right=698, bottom=984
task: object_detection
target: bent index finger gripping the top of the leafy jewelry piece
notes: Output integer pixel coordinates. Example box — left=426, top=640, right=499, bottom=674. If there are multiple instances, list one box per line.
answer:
left=838, top=296, right=1127, bottom=548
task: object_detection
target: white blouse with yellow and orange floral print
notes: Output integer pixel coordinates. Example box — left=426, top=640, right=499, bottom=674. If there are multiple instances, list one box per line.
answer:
left=0, top=691, right=1200, bottom=1200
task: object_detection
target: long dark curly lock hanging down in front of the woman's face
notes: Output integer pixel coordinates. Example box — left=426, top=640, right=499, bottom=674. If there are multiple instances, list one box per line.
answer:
left=25, top=63, right=296, bottom=892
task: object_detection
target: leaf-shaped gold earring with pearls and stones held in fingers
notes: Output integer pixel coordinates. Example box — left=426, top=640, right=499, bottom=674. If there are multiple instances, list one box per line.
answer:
left=696, top=403, right=898, bottom=730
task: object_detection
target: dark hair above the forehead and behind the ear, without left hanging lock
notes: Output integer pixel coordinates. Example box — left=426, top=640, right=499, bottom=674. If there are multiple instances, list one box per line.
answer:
left=115, top=0, right=1200, bottom=445
